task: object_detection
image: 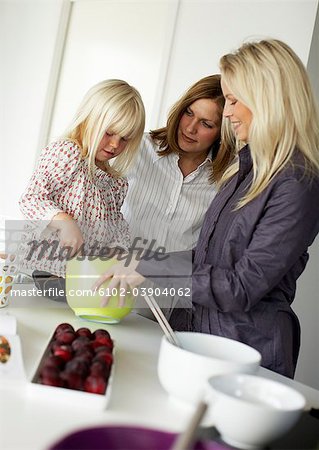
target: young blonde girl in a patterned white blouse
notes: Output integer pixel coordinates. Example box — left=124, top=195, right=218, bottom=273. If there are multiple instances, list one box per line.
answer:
left=20, top=80, right=145, bottom=300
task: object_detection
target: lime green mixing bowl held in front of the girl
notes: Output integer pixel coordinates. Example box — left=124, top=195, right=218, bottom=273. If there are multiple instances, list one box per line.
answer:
left=66, top=257, right=134, bottom=324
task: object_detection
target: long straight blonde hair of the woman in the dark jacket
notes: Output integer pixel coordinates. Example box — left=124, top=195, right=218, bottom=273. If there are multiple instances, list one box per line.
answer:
left=220, top=39, right=319, bottom=208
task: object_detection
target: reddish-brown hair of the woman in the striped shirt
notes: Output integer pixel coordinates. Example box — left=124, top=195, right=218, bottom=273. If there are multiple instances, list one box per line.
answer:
left=150, top=74, right=234, bottom=182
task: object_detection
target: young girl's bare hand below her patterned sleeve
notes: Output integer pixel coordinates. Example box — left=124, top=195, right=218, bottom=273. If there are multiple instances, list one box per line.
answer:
left=49, top=213, right=84, bottom=256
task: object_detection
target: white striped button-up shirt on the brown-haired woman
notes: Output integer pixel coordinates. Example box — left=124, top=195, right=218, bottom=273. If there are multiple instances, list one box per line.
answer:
left=122, top=133, right=216, bottom=251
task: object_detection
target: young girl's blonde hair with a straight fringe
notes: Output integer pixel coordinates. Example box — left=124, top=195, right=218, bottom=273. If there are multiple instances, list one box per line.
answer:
left=63, top=79, right=145, bottom=177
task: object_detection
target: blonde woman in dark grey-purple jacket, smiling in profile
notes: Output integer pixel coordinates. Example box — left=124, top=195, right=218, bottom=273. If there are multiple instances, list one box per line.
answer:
left=96, top=39, right=319, bottom=377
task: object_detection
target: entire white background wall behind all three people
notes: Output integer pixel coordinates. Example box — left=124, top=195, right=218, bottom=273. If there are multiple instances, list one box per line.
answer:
left=0, top=0, right=319, bottom=388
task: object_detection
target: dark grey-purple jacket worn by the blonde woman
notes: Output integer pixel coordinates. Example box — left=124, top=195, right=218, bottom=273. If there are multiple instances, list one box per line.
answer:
left=138, top=146, right=319, bottom=377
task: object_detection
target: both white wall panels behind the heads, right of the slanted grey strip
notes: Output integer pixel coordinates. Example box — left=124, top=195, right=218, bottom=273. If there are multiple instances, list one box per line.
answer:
left=50, top=0, right=318, bottom=136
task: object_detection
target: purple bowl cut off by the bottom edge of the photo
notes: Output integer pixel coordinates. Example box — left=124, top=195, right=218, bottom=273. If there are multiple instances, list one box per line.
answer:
left=49, top=426, right=228, bottom=450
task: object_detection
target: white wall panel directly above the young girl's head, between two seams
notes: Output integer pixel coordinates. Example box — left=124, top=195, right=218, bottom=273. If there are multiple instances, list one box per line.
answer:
left=50, top=0, right=176, bottom=136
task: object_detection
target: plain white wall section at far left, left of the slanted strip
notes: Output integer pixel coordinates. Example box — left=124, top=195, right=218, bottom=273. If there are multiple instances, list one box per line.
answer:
left=0, top=0, right=62, bottom=217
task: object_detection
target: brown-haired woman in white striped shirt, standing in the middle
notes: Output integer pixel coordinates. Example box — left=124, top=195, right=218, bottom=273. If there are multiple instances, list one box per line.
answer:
left=122, top=75, right=233, bottom=317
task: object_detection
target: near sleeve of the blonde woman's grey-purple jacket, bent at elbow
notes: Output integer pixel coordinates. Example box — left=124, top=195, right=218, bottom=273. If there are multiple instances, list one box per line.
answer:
left=192, top=179, right=319, bottom=312
